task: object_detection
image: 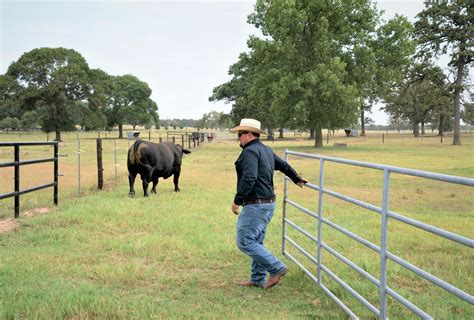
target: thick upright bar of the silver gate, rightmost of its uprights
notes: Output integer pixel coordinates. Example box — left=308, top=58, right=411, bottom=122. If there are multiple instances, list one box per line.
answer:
left=380, top=168, right=390, bottom=319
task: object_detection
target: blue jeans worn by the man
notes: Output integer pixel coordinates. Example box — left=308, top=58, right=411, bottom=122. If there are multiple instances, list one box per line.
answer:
left=236, top=203, right=285, bottom=286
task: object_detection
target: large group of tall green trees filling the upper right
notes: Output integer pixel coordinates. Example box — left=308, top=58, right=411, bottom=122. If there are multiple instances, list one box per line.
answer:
left=209, top=0, right=474, bottom=147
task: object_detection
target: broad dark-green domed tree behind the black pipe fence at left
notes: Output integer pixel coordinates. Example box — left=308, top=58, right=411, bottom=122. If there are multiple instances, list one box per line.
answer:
left=7, top=48, right=92, bottom=141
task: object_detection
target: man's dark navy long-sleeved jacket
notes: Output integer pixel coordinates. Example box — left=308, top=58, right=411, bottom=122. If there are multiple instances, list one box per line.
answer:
left=234, top=139, right=301, bottom=205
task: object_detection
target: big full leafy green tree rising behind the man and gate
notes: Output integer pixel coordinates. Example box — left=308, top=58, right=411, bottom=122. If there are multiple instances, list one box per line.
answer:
left=249, top=0, right=373, bottom=147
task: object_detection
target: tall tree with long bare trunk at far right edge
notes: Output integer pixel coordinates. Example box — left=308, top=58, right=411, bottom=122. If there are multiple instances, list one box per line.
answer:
left=415, top=0, right=474, bottom=145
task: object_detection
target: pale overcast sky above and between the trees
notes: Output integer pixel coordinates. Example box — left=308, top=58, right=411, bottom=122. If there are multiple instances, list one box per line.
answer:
left=0, top=0, right=430, bottom=124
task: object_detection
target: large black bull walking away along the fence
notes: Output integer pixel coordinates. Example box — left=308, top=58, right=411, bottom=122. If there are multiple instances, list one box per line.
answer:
left=127, top=140, right=191, bottom=197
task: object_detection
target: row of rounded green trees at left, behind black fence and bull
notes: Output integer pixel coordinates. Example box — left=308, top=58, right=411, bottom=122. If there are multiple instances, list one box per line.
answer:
left=0, top=48, right=159, bottom=141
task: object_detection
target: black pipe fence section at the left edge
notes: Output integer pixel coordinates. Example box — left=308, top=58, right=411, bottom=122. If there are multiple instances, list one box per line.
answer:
left=0, top=141, right=58, bottom=219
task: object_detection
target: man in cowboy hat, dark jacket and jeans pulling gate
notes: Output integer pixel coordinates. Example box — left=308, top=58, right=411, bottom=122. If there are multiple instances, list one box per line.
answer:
left=231, top=119, right=308, bottom=289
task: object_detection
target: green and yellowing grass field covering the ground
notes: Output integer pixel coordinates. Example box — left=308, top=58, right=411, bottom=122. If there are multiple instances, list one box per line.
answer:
left=0, top=133, right=474, bottom=319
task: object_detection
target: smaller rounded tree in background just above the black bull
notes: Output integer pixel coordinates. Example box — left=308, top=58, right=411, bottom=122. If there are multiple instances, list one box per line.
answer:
left=106, top=74, right=159, bottom=138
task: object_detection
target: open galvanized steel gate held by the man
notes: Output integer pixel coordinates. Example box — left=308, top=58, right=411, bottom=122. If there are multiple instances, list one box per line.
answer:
left=282, top=150, right=474, bottom=319
